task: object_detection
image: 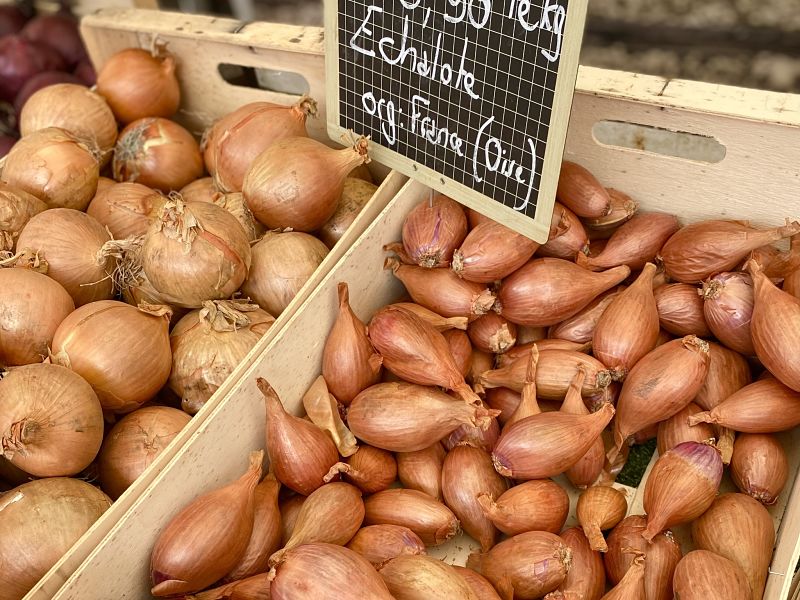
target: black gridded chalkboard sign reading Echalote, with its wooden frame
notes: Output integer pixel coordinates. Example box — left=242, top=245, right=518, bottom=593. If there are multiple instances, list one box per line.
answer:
left=325, top=0, right=587, bottom=242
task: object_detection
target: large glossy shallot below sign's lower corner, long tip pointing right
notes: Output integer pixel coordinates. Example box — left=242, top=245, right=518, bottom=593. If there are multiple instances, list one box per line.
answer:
left=497, top=258, right=630, bottom=327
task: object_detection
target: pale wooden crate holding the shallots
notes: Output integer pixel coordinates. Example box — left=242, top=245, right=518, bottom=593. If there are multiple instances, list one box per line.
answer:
left=39, top=63, right=800, bottom=600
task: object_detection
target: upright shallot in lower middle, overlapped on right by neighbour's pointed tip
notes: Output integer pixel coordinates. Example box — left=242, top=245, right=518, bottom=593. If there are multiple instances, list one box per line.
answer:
left=442, top=445, right=508, bottom=552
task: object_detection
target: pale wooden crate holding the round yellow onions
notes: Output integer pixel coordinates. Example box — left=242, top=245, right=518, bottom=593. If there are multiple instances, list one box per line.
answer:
left=14, top=8, right=407, bottom=599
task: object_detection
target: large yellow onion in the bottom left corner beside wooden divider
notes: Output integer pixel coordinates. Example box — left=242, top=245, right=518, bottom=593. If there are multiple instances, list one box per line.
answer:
left=0, top=477, right=111, bottom=600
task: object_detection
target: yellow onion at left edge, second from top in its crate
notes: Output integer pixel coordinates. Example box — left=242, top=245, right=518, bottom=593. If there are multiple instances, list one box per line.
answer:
left=3, top=127, right=100, bottom=210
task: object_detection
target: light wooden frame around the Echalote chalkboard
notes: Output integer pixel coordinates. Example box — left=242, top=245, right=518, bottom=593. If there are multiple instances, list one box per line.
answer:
left=325, top=0, right=588, bottom=243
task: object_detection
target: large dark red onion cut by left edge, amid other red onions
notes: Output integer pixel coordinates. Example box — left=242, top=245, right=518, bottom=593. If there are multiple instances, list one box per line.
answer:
left=0, top=35, right=66, bottom=102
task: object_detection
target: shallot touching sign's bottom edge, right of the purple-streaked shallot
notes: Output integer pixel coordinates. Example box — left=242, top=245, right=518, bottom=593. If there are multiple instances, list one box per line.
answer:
left=452, top=221, right=539, bottom=283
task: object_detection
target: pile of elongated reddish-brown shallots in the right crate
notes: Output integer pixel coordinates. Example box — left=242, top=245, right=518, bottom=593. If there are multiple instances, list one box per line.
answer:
left=151, top=163, right=800, bottom=600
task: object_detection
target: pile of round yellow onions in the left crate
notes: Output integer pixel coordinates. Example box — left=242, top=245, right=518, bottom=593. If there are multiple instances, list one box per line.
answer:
left=0, top=43, right=376, bottom=600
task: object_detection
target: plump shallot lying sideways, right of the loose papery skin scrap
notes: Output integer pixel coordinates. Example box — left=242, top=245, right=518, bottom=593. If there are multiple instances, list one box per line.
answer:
left=348, top=382, right=496, bottom=452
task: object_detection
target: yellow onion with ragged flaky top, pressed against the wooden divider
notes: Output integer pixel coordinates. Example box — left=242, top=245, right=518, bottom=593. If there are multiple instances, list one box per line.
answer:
left=169, top=300, right=275, bottom=415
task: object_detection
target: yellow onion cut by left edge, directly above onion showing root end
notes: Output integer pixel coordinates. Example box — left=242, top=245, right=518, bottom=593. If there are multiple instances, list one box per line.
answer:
left=0, top=268, right=75, bottom=367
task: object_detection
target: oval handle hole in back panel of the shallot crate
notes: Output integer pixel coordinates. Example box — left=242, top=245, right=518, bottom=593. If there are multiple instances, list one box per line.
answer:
left=592, top=121, right=727, bottom=164
